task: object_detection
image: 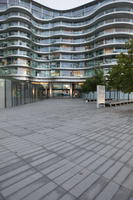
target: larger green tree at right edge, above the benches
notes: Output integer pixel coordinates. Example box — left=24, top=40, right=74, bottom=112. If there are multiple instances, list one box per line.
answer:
left=108, top=39, right=133, bottom=93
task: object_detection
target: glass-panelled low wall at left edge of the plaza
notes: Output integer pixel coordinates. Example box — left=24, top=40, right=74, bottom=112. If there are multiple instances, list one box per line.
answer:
left=0, top=79, right=43, bottom=108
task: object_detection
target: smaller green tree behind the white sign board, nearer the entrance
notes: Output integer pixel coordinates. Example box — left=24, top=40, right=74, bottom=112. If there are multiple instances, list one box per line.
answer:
left=82, top=69, right=105, bottom=92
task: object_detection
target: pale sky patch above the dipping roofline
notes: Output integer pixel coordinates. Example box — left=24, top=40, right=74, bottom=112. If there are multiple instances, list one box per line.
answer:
left=35, top=0, right=92, bottom=10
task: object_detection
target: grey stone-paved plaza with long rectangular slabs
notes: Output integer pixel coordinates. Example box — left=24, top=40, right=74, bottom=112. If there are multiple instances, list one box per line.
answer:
left=0, top=99, right=133, bottom=200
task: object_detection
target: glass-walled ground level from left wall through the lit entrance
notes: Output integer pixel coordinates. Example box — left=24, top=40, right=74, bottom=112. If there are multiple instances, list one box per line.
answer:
left=0, top=79, right=81, bottom=108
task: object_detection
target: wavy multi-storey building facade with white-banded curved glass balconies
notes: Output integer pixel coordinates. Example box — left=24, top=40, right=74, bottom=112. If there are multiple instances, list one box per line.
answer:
left=0, top=0, right=133, bottom=96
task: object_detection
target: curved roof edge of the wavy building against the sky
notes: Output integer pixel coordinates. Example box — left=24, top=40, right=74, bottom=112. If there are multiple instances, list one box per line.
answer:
left=32, top=0, right=100, bottom=12
